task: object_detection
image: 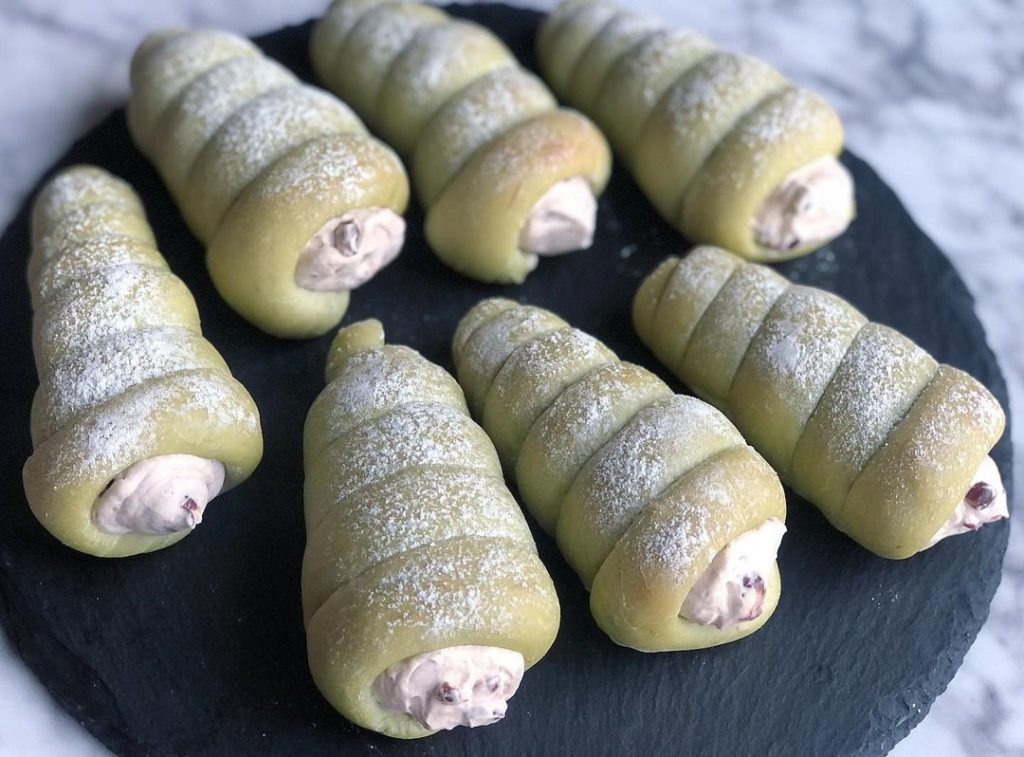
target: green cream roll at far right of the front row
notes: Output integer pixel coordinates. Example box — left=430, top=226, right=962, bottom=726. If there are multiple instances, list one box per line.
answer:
left=633, top=247, right=1009, bottom=559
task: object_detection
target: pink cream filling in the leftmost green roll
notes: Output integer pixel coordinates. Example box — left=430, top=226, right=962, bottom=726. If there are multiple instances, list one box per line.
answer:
left=92, top=455, right=224, bottom=534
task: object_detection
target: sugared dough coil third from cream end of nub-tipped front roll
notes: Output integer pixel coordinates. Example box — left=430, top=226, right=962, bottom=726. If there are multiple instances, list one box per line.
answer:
left=314, top=403, right=501, bottom=510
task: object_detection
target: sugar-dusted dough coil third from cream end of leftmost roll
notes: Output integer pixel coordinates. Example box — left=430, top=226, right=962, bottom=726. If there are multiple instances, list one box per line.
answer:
left=38, top=265, right=199, bottom=366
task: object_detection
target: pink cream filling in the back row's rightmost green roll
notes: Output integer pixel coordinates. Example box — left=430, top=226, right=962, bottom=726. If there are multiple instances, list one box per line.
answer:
left=753, top=156, right=853, bottom=251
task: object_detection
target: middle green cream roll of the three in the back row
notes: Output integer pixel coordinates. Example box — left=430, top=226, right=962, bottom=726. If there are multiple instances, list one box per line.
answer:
left=310, top=0, right=610, bottom=284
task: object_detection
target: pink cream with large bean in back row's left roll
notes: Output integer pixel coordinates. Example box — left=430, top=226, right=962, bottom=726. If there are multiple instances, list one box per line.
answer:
left=295, top=208, right=406, bottom=292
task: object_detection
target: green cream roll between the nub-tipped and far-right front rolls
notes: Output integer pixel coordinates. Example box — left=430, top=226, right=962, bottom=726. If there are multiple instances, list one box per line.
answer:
left=453, top=299, right=785, bottom=651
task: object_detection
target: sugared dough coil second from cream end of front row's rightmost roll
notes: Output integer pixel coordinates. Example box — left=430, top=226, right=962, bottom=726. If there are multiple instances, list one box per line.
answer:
left=815, top=324, right=936, bottom=479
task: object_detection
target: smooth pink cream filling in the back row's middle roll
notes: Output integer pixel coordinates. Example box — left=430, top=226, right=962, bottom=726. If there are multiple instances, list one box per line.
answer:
left=519, top=176, right=597, bottom=255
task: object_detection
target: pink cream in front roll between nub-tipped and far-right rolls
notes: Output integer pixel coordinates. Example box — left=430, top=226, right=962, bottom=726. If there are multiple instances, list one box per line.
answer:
left=679, top=517, right=785, bottom=630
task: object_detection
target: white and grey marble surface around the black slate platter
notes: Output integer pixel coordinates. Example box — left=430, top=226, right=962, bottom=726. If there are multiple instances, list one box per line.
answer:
left=0, top=0, right=1024, bottom=757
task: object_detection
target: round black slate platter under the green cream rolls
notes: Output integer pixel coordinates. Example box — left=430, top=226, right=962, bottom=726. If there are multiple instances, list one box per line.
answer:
left=0, top=5, right=1011, bottom=755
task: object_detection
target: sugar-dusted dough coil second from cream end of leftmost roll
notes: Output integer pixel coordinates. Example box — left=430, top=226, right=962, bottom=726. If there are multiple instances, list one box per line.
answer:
left=39, top=327, right=219, bottom=444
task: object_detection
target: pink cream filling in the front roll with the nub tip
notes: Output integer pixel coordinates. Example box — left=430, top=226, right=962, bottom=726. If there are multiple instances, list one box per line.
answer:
left=374, top=645, right=525, bottom=730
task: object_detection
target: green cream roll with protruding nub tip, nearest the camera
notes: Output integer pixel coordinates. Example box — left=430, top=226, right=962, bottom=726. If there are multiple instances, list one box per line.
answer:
left=302, top=321, right=559, bottom=739
